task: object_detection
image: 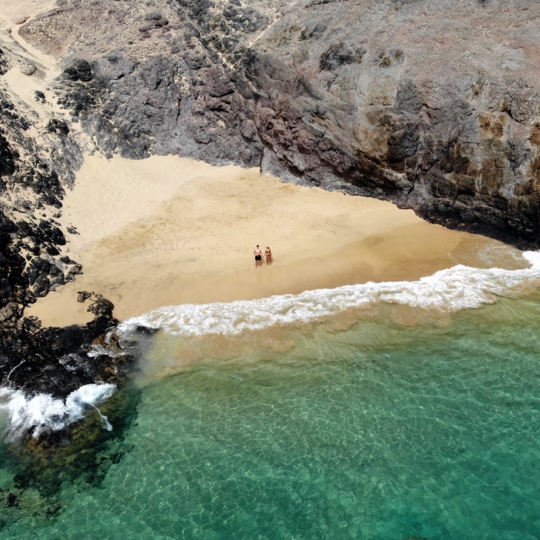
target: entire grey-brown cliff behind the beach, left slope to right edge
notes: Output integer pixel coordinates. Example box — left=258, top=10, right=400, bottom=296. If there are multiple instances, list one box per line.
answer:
left=17, top=0, right=540, bottom=247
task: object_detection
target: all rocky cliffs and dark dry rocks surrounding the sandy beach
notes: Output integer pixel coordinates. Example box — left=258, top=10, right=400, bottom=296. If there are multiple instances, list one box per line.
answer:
left=0, top=0, right=540, bottom=448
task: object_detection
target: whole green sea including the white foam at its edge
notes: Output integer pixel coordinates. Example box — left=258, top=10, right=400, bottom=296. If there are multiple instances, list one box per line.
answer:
left=0, top=244, right=540, bottom=540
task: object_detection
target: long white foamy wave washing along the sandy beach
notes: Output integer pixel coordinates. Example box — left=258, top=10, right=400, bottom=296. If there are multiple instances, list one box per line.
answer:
left=119, top=252, right=540, bottom=336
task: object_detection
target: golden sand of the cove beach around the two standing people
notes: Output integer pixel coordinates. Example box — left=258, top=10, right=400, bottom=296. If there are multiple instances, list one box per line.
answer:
left=23, top=156, right=512, bottom=325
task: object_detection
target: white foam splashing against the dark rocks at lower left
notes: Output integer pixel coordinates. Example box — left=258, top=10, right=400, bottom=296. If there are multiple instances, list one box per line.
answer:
left=0, top=384, right=116, bottom=440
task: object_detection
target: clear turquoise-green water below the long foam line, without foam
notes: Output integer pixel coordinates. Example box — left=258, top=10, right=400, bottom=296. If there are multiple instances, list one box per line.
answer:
left=0, top=297, right=540, bottom=540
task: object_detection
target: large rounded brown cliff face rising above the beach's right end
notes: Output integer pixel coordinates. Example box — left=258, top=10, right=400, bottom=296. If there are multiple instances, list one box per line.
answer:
left=243, top=0, right=540, bottom=246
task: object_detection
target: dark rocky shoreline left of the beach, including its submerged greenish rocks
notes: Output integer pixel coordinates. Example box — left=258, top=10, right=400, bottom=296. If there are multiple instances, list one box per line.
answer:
left=0, top=43, right=138, bottom=502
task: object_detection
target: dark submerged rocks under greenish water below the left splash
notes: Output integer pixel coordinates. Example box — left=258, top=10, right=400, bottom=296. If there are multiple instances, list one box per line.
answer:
left=0, top=387, right=140, bottom=531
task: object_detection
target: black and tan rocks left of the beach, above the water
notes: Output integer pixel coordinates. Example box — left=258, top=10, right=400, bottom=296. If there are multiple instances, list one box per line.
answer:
left=0, top=45, right=133, bottom=398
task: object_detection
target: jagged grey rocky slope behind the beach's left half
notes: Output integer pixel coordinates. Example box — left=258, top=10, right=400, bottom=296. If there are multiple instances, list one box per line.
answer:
left=21, top=0, right=262, bottom=166
